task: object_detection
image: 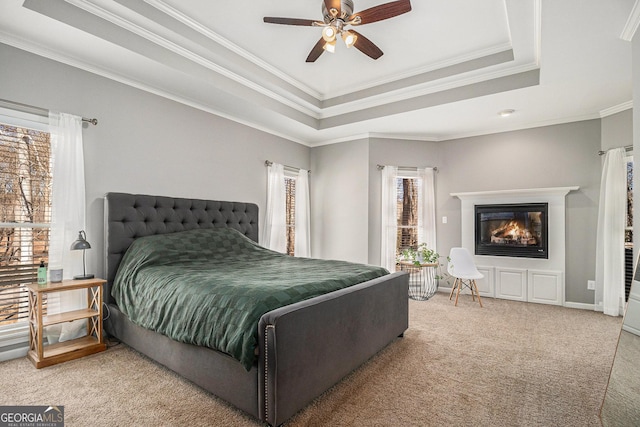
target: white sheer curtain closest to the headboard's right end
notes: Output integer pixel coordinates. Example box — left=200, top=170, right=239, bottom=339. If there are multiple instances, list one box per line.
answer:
left=261, top=163, right=287, bottom=253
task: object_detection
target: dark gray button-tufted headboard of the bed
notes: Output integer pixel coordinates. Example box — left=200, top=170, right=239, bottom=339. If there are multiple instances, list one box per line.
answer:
left=104, top=193, right=258, bottom=303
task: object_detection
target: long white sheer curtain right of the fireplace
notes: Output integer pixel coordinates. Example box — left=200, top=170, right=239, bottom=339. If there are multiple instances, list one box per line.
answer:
left=595, top=148, right=627, bottom=316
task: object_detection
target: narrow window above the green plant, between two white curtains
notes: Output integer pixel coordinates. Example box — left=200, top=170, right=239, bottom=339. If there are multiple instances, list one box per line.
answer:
left=396, top=176, right=422, bottom=255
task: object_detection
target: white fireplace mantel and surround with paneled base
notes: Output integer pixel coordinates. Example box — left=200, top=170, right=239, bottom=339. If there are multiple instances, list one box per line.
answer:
left=451, top=186, right=580, bottom=305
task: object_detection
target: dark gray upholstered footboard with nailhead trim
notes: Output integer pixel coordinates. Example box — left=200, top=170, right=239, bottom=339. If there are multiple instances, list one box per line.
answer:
left=258, top=273, right=409, bottom=426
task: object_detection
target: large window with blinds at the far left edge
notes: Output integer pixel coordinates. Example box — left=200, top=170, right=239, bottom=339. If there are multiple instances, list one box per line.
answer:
left=0, top=122, right=51, bottom=327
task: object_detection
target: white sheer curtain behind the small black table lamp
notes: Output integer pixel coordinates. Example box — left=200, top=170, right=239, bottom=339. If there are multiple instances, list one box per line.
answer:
left=49, top=112, right=86, bottom=311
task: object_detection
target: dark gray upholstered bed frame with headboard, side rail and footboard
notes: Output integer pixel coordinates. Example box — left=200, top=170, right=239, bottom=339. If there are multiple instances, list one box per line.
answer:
left=104, top=193, right=408, bottom=425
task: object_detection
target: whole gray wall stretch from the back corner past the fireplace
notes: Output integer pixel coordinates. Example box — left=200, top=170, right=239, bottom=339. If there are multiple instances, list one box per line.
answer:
left=311, top=120, right=608, bottom=304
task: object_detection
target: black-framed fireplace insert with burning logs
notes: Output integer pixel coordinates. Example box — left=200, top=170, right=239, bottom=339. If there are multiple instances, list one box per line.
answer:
left=475, top=203, right=549, bottom=259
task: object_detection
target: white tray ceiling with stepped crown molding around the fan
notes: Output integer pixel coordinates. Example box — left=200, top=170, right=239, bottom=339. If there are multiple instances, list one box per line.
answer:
left=0, top=0, right=634, bottom=146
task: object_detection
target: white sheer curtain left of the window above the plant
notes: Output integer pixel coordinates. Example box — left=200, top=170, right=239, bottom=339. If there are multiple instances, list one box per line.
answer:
left=380, top=166, right=398, bottom=272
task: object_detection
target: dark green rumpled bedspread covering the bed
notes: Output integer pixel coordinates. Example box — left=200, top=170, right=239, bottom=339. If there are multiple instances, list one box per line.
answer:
left=112, top=228, right=388, bottom=370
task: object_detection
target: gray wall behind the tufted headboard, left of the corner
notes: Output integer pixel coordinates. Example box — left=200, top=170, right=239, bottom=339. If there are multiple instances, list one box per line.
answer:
left=0, top=44, right=310, bottom=275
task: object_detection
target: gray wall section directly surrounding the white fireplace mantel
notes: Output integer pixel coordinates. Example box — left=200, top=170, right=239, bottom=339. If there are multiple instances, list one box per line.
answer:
left=437, top=120, right=601, bottom=304
